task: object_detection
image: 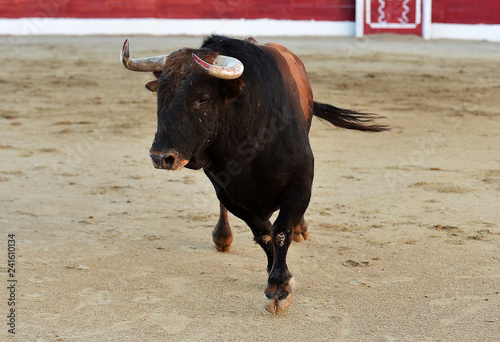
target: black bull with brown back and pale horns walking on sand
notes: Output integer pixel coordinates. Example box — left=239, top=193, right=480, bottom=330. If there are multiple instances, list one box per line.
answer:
left=121, top=35, right=388, bottom=314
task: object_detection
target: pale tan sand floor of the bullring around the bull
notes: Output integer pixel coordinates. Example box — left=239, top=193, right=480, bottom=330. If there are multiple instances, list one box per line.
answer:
left=0, top=35, right=500, bottom=341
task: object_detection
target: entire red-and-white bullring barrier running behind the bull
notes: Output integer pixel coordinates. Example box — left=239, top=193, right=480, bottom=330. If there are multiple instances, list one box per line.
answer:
left=0, top=0, right=500, bottom=41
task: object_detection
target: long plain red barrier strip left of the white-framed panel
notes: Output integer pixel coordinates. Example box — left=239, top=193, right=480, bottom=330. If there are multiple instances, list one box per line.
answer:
left=0, top=0, right=356, bottom=21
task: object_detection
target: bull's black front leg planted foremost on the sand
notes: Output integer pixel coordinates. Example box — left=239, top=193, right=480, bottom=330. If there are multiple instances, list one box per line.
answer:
left=264, top=177, right=312, bottom=315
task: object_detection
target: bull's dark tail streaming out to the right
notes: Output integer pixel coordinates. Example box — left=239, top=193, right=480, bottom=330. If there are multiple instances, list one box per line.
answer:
left=313, top=101, right=390, bottom=132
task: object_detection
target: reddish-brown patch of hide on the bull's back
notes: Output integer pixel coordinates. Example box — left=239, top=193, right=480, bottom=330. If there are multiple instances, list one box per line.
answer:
left=258, top=43, right=313, bottom=130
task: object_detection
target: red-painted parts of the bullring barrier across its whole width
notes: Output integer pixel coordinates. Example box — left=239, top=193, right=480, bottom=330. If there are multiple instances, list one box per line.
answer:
left=0, top=0, right=500, bottom=25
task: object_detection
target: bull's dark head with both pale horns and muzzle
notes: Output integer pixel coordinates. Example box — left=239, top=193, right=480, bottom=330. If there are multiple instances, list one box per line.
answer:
left=120, top=40, right=245, bottom=170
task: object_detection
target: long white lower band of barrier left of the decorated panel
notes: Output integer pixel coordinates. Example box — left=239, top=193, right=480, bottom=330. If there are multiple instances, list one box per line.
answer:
left=0, top=18, right=355, bottom=36
